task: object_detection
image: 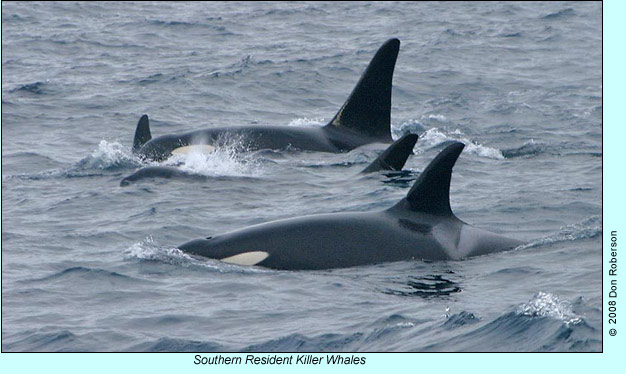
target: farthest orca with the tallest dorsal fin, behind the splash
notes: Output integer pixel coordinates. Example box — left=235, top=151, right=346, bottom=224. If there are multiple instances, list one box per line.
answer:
left=132, top=39, right=400, bottom=161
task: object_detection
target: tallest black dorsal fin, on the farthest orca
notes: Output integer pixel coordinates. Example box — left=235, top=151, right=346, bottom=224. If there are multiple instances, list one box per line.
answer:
left=326, top=39, right=400, bottom=142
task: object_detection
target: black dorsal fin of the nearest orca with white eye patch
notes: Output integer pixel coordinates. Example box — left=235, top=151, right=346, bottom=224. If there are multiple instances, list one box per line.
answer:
left=396, top=142, right=465, bottom=216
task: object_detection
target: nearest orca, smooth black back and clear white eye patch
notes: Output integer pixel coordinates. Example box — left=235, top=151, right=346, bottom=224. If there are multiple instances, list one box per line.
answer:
left=179, top=143, right=523, bottom=270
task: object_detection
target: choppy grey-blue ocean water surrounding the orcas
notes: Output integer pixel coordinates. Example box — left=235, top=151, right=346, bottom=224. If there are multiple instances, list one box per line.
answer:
left=2, top=2, right=602, bottom=352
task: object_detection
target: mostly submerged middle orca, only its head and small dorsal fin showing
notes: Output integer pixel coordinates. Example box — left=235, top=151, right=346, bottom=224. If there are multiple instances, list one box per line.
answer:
left=120, top=134, right=418, bottom=186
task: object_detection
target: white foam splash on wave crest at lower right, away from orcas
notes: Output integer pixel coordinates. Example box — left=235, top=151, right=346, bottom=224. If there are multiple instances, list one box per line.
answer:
left=516, top=291, right=583, bottom=326
